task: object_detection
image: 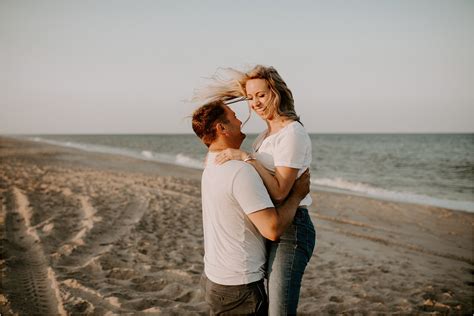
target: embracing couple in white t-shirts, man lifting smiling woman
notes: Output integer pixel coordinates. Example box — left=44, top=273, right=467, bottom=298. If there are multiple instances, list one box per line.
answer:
left=192, top=65, right=316, bottom=315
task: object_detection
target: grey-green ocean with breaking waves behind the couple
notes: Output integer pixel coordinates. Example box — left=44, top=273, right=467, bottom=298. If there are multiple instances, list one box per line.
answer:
left=25, top=134, right=474, bottom=212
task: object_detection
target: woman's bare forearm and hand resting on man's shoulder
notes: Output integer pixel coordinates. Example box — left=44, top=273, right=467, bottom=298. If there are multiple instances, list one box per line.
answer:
left=216, top=149, right=299, bottom=204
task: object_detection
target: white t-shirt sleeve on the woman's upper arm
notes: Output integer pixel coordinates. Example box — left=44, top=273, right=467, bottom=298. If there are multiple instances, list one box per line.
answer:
left=273, top=130, right=309, bottom=169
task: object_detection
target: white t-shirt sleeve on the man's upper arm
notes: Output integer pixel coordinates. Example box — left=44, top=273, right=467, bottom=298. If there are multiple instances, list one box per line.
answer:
left=232, top=165, right=274, bottom=214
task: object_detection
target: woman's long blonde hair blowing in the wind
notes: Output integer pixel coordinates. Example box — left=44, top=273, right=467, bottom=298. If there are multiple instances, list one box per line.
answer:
left=193, top=65, right=299, bottom=121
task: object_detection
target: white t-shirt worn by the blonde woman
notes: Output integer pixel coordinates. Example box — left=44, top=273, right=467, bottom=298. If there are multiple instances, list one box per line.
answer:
left=253, top=122, right=313, bottom=206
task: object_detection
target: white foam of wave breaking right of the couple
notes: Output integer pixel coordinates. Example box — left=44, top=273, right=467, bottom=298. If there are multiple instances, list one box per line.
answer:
left=311, top=178, right=474, bottom=212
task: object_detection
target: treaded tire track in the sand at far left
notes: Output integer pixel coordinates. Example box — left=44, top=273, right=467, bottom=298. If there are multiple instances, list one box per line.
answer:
left=3, top=187, right=66, bottom=315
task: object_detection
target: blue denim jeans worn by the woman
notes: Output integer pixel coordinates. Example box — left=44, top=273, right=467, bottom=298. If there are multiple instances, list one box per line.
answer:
left=267, top=207, right=316, bottom=316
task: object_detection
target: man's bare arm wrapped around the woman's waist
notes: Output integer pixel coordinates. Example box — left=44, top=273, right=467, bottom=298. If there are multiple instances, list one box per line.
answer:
left=248, top=170, right=310, bottom=241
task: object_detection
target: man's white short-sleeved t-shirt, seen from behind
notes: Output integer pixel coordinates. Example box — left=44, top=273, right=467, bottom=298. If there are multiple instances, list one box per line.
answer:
left=201, top=152, right=273, bottom=285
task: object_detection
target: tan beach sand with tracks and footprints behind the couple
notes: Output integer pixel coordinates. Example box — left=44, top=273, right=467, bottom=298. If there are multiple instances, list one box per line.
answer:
left=0, top=138, right=474, bottom=315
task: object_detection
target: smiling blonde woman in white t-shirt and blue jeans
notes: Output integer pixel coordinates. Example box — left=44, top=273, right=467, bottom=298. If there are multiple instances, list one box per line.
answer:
left=203, top=65, right=316, bottom=315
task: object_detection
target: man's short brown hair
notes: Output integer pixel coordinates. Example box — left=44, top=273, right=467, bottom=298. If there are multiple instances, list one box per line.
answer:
left=192, top=100, right=227, bottom=147
